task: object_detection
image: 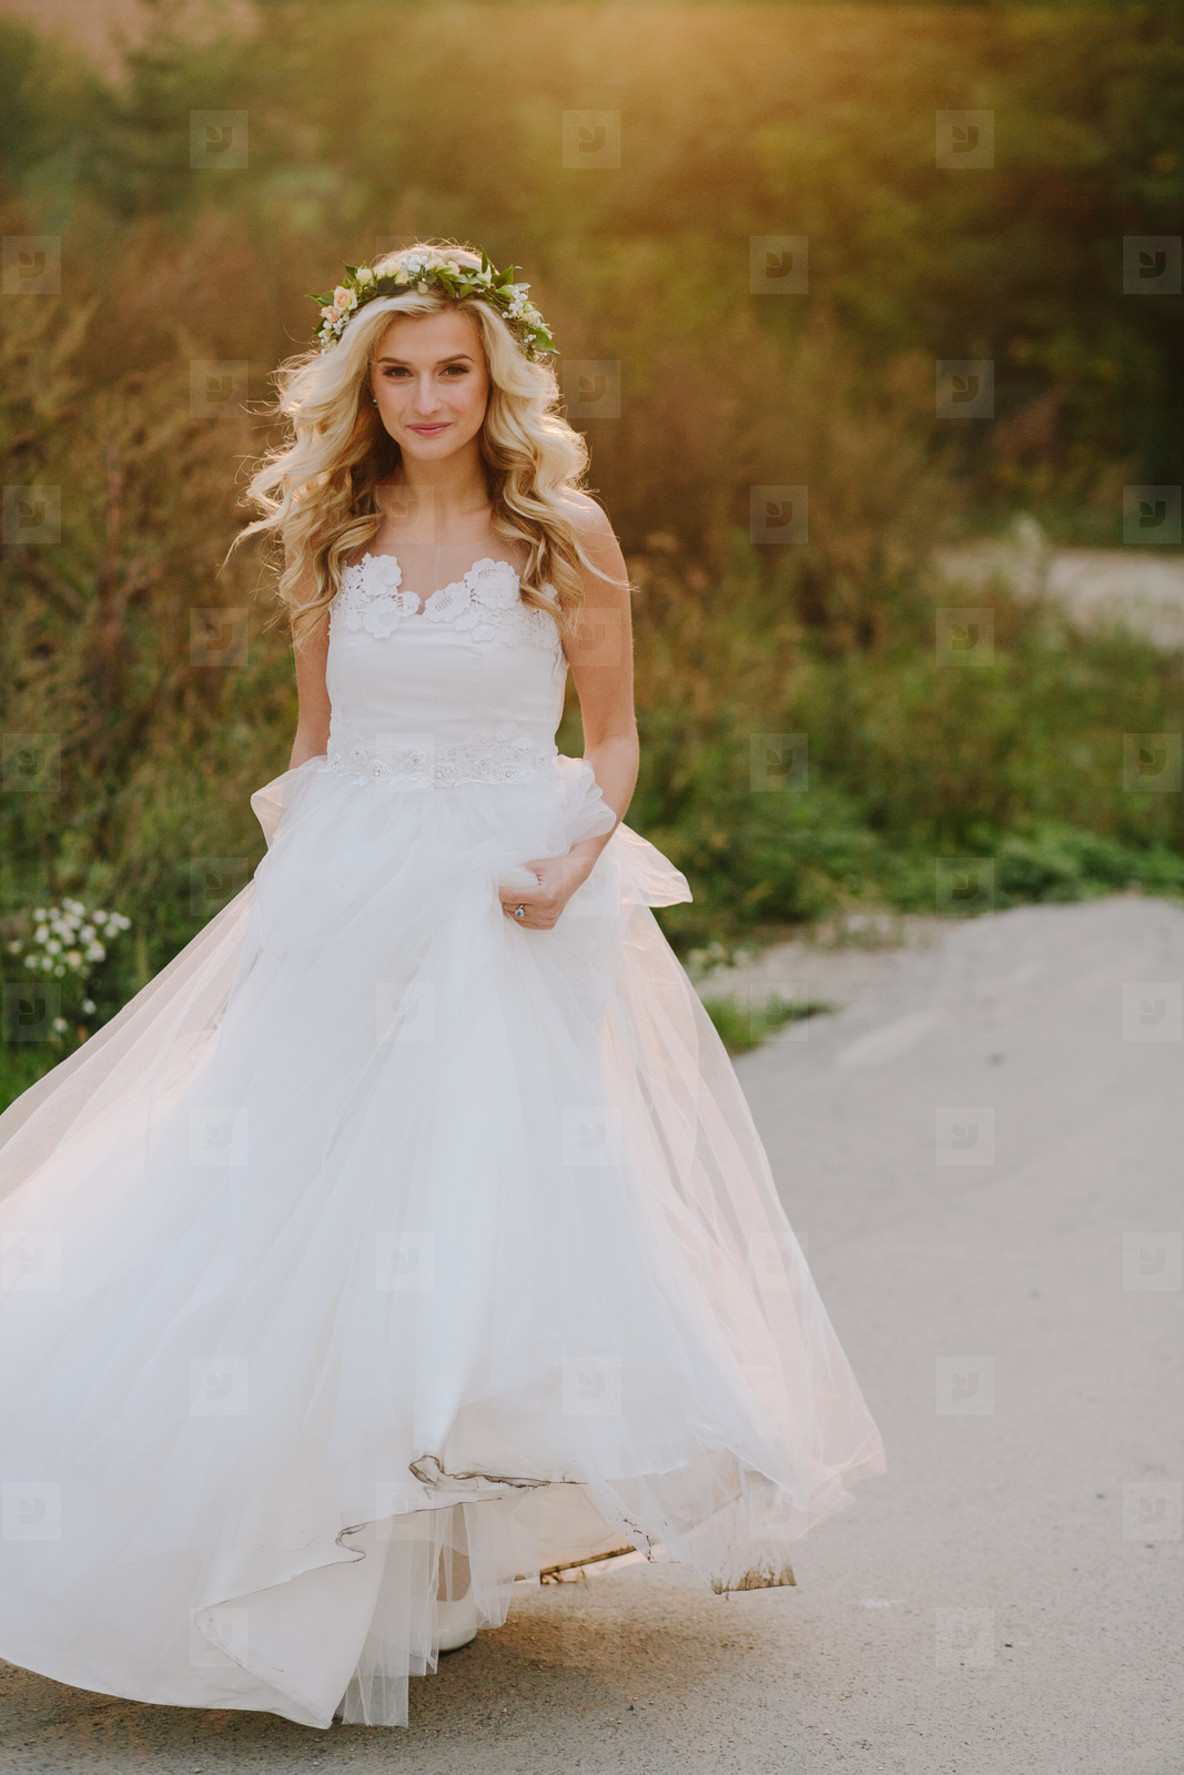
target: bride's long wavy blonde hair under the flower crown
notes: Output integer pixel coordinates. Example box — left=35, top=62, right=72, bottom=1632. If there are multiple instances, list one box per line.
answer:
left=236, top=243, right=605, bottom=644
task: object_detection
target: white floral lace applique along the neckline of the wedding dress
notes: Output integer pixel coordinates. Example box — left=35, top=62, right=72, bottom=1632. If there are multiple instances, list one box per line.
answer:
left=334, top=552, right=559, bottom=648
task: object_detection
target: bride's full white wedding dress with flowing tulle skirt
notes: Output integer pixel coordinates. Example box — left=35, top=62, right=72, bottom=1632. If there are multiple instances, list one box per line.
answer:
left=0, top=556, right=884, bottom=1727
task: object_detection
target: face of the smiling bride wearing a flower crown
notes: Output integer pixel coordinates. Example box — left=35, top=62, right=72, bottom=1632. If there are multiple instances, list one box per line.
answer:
left=369, top=309, right=490, bottom=462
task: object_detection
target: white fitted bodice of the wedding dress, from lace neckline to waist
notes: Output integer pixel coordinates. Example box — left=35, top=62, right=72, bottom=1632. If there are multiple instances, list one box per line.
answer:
left=325, top=554, right=566, bottom=785
